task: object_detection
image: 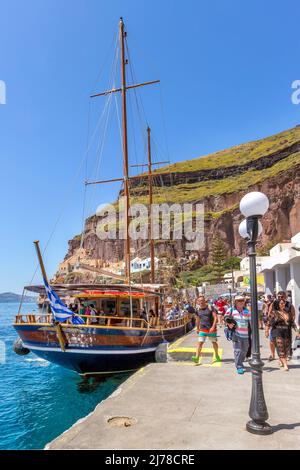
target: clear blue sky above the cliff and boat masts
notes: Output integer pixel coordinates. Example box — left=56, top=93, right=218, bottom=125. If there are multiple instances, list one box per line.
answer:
left=0, top=0, right=300, bottom=293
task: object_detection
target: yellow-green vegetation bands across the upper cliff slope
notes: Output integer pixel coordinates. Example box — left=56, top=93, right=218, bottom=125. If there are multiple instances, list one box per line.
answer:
left=131, top=127, right=300, bottom=208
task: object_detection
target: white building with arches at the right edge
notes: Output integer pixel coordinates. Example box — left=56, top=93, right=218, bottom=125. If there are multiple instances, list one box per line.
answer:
left=260, top=232, right=300, bottom=312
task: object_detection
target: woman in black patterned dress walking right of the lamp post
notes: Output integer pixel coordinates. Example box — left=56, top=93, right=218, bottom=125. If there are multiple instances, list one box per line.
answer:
left=266, top=298, right=297, bottom=371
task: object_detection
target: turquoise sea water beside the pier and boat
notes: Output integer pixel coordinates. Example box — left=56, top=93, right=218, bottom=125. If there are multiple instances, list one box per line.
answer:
left=0, top=303, right=128, bottom=450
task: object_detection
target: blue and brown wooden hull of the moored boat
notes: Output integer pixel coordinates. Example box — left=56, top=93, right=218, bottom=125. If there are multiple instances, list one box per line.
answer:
left=14, top=324, right=192, bottom=375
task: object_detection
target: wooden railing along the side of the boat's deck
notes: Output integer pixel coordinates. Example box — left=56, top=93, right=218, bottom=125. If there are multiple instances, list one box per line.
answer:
left=15, top=312, right=189, bottom=329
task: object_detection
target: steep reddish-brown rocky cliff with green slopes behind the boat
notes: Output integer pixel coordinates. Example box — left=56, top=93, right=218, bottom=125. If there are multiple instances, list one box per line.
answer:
left=62, top=126, right=300, bottom=274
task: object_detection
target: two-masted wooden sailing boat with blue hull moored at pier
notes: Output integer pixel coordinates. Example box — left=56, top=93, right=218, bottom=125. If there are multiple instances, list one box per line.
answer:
left=13, top=18, right=192, bottom=375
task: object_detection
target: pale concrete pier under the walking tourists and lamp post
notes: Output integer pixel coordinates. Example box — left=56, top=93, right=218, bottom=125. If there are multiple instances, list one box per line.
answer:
left=46, top=329, right=300, bottom=450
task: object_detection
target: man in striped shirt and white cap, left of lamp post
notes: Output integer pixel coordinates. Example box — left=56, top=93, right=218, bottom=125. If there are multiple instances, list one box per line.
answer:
left=231, top=296, right=251, bottom=374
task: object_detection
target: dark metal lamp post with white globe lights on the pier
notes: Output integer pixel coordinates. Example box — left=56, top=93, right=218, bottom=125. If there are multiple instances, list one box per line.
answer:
left=239, top=192, right=273, bottom=435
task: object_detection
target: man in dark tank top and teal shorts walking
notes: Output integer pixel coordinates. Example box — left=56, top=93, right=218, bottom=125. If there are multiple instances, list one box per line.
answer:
left=193, top=295, right=221, bottom=366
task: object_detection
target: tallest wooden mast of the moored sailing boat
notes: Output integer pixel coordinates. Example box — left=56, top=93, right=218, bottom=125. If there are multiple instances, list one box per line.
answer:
left=119, top=18, right=130, bottom=284
